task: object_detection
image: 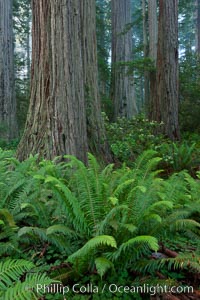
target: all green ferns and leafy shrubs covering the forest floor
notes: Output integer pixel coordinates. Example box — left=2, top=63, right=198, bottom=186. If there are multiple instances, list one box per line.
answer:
left=0, top=121, right=200, bottom=300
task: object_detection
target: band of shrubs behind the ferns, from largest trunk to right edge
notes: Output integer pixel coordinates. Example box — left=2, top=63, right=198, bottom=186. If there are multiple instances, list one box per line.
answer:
left=104, top=115, right=200, bottom=176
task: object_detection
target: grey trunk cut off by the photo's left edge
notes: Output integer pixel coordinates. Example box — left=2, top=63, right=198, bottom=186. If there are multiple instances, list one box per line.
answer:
left=0, top=0, right=18, bottom=141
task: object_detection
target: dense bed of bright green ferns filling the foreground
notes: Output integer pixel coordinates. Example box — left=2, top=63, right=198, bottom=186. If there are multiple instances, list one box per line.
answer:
left=0, top=150, right=200, bottom=299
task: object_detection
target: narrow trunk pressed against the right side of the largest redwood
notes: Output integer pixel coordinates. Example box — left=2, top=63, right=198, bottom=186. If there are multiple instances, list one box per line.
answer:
left=80, top=0, right=111, bottom=161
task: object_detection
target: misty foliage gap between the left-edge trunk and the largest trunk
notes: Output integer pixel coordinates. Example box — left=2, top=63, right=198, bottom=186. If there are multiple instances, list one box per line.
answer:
left=13, top=0, right=31, bottom=131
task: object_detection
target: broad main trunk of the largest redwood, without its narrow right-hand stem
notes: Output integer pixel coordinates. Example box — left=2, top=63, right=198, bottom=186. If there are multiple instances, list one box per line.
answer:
left=17, top=0, right=88, bottom=161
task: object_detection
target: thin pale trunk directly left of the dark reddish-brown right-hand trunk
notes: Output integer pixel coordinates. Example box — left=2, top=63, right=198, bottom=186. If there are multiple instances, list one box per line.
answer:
left=148, top=0, right=158, bottom=119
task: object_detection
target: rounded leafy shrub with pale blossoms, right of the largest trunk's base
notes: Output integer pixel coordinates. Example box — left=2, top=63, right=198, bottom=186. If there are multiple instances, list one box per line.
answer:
left=106, top=115, right=164, bottom=165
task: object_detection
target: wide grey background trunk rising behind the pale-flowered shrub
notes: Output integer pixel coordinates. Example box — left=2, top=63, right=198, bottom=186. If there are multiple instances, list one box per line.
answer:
left=111, top=0, right=137, bottom=119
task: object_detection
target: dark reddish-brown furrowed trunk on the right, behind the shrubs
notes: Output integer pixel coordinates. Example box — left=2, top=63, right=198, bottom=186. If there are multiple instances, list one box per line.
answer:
left=153, top=0, right=180, bottom=140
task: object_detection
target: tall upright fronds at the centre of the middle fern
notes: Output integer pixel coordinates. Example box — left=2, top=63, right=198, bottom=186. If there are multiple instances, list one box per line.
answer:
left=64, top=154, right=112, bottom=236
